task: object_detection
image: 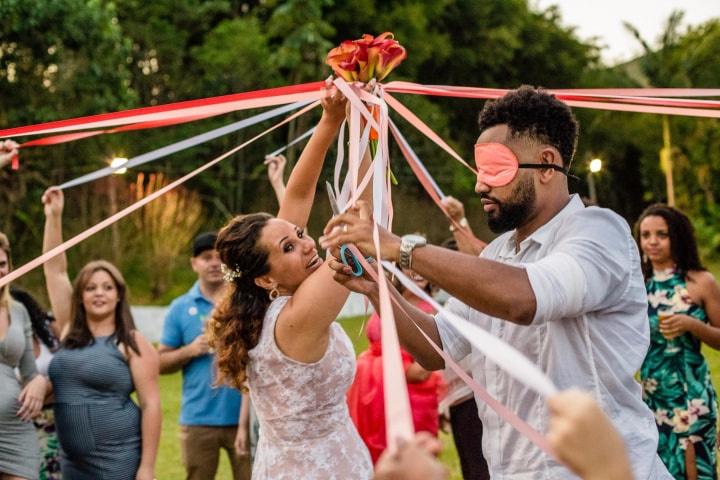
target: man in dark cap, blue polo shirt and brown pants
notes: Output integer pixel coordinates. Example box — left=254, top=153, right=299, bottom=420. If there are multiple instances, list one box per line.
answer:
left=159, top=232, right=250, bottom=480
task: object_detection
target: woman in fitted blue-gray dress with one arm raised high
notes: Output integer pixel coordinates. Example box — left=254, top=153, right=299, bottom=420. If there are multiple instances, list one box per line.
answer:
left=43, top=188, right=161, bottom=480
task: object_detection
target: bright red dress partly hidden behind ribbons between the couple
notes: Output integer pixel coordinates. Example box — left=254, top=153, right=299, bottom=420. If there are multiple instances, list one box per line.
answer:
left=347, top=301, right=445, bottom=463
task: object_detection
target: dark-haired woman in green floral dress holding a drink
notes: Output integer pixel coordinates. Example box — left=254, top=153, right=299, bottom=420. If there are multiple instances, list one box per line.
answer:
left=636, top=204, right=720, bottom=480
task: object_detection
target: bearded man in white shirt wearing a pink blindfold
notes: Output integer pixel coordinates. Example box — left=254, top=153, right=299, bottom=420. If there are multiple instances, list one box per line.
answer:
left=320, top=86, right=671, bottom=480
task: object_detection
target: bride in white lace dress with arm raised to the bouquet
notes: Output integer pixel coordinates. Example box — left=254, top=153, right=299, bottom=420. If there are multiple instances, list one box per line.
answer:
left=209, top=86, right=372, bottom=480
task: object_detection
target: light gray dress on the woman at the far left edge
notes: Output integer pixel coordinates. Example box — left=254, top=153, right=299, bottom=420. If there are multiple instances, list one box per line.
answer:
left=0, top=300, right=40, bottom=479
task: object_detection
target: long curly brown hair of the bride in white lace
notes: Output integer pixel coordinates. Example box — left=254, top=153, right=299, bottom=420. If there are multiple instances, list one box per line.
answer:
left=207, top=213, right=273, bottom=391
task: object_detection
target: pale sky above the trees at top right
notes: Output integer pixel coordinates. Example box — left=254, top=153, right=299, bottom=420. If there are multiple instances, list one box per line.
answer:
left=531, top=0, right=720, bottom=65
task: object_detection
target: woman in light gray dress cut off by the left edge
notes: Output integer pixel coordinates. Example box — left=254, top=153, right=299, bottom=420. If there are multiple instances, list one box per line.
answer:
left=0, top=233, right=47, bottom=480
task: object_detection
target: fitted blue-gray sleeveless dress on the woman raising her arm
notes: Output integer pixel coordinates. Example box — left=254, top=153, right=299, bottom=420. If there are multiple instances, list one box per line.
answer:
left=49, top=336, right=142, bottom=480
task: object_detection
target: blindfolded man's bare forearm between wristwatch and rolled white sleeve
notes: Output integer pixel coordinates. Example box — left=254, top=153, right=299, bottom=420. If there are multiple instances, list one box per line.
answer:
left=412, top=245, right=536, bottom=325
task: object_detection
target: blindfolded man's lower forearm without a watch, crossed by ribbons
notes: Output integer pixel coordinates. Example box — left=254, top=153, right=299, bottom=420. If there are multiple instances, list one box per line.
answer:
left=368, top=287, right=445, bottom=370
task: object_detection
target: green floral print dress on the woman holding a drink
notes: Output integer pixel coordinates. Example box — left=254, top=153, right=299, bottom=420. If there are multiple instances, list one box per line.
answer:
left=640, top=270, right=717, bottom=479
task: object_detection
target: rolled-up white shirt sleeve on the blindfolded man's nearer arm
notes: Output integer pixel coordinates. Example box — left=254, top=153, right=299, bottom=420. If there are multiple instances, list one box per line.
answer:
left=525, top=208, right=637, bottom=322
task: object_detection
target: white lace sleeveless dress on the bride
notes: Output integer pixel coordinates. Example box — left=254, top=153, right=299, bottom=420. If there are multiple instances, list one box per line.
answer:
left=248, top=297, right=373, bottom=480
